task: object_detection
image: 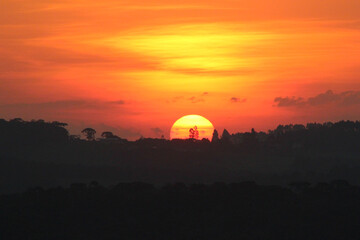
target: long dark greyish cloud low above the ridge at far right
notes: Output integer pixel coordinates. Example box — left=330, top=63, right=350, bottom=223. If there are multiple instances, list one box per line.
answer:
left=274, top=90, right=360, bottom=107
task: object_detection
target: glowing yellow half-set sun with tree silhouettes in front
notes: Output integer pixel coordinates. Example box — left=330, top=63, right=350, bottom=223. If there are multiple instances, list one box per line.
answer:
left=170, top=115, right=214, bottom=140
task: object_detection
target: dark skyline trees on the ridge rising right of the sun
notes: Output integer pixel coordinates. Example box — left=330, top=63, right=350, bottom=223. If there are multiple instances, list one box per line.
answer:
left=221, top=121, right=360, bottom=151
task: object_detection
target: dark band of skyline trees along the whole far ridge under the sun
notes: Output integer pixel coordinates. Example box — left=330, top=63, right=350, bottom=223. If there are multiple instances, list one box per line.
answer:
left=0, top=118, right=360, bottom=151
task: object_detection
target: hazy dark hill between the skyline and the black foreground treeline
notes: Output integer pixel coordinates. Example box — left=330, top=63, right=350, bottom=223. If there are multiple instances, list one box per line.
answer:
left=0, top=119, right=360, bottom=193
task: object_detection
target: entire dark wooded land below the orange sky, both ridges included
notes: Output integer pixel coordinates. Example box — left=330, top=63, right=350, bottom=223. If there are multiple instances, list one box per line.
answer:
left=0, top=119, right=360, bottom=240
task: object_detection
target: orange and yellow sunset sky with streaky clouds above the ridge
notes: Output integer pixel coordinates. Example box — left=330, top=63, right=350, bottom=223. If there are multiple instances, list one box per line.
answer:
left=0, top=0, right=360, bottom=139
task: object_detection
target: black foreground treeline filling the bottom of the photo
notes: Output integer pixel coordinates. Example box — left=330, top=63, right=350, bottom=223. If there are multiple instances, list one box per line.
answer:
left=0, top=180, right=360, bottom=240
